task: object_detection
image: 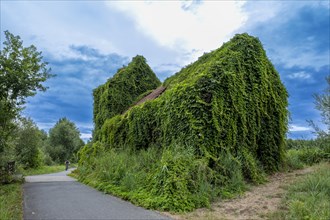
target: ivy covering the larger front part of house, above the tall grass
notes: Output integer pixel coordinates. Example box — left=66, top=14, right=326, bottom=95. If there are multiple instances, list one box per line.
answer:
left=94, top=34, right=288, bottom=174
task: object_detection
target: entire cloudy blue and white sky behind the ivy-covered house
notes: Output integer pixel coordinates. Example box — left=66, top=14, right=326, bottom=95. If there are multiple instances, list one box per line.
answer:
left=0, top=0, right=330, bottom=140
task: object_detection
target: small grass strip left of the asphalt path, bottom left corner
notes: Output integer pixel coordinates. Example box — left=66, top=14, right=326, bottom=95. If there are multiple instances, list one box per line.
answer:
left=0, top=183, right=23, bottom=219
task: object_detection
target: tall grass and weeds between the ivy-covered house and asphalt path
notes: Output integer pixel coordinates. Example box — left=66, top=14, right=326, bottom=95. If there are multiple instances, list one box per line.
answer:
left=77, top=146, right=245, bottom=212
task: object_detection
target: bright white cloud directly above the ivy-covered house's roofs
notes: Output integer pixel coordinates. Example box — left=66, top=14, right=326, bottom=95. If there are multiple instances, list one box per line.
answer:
left=107, top=1, right=246, bottom=58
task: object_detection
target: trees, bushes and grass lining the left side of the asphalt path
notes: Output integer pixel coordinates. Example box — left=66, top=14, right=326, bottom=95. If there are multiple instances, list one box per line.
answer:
left=0, top=31, right=84, bottom=219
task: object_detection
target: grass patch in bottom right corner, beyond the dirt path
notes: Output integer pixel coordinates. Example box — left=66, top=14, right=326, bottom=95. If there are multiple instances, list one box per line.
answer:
left=270, top=163, right=330, bottom=219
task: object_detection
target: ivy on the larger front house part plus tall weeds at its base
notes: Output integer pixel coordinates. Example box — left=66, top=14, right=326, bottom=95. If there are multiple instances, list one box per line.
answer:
left=79, top=34, right=288, bottom=211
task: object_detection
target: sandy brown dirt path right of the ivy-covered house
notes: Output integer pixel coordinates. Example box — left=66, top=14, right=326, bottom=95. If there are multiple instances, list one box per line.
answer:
left=169, top=167, right=313, bottom=220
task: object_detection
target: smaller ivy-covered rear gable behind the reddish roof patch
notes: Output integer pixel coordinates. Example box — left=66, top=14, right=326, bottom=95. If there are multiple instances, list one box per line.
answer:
left=93, top=56, right=160, bottom=140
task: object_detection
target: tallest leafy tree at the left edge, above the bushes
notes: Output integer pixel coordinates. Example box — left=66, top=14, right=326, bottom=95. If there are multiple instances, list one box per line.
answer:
left=0, top=31, right=53, bottom=157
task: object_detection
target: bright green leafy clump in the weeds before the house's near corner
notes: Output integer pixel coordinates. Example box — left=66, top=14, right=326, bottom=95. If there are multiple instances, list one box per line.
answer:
left=149, top=146, right=211, bottom=212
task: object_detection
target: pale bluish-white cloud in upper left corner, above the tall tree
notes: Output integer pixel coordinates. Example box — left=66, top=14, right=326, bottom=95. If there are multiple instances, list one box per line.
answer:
left=1, top=1, right=124, bottom=59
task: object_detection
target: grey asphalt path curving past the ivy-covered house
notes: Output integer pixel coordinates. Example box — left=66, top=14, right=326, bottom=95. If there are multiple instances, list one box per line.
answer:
left=23, top=171, right=170, bottom=219
